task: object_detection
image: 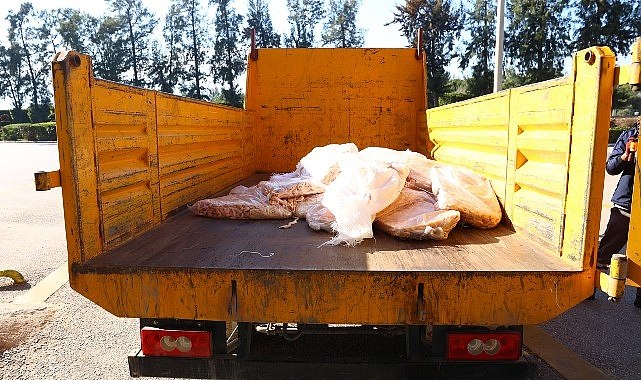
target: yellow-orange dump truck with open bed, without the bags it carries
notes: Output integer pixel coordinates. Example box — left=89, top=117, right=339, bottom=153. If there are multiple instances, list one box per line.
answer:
left=36, top=40, right=641, bottom=379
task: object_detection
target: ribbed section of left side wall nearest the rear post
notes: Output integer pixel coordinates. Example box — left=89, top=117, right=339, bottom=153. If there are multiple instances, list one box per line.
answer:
left=92, top=80, right=160, bottom=249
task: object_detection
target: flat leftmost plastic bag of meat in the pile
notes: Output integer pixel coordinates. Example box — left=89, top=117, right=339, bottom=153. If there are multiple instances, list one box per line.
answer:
left=189, top=185, right=292, bottom=219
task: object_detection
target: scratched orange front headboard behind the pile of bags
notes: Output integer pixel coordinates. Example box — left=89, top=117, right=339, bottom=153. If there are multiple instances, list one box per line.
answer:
left=247, top=49, right=427, bottom=172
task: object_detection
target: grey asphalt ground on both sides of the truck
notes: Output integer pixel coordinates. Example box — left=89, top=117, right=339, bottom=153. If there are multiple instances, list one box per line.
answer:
left=0, top=142, right=641, bottom=380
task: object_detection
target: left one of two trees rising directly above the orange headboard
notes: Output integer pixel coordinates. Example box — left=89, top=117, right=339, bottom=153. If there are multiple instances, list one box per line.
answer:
left=285, top=0, right=325, bottom=48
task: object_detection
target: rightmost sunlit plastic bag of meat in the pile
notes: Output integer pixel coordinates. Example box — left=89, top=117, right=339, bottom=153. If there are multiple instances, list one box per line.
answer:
left=430, top=164, right=503, bottom=229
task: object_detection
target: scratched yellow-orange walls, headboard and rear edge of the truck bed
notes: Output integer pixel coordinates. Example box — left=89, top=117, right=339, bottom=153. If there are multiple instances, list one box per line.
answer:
left=53, top=49, right=620, bottom=325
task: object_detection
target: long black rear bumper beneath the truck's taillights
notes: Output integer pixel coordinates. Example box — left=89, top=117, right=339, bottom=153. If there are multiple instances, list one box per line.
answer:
left=129, top=351, right=536, bottom=380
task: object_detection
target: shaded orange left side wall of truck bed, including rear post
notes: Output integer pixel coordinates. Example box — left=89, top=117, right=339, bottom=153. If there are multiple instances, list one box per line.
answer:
left=53, top=52, right=254, bottom=265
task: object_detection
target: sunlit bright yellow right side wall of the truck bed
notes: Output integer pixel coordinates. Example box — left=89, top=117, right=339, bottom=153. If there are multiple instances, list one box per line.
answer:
left=427, top=48, right=614, bottom=270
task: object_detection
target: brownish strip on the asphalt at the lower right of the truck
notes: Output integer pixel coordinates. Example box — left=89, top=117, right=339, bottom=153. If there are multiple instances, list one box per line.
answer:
left=523, top=326, right=611, bottom=380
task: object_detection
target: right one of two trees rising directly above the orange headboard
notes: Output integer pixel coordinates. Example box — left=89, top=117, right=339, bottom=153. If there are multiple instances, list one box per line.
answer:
left=321, top=0, right=364, bottom=48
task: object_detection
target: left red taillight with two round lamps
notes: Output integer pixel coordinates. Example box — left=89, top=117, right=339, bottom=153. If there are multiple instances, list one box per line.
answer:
left=140, top=327, right=212, bottom=358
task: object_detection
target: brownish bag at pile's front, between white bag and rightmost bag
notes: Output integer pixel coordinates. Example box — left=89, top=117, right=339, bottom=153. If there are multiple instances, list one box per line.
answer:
left=375, top=187, right=461, bottom=240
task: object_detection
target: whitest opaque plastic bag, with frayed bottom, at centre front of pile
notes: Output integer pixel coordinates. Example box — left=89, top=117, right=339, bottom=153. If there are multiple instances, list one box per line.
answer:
left=322, top=156, right=409, bottom=246
